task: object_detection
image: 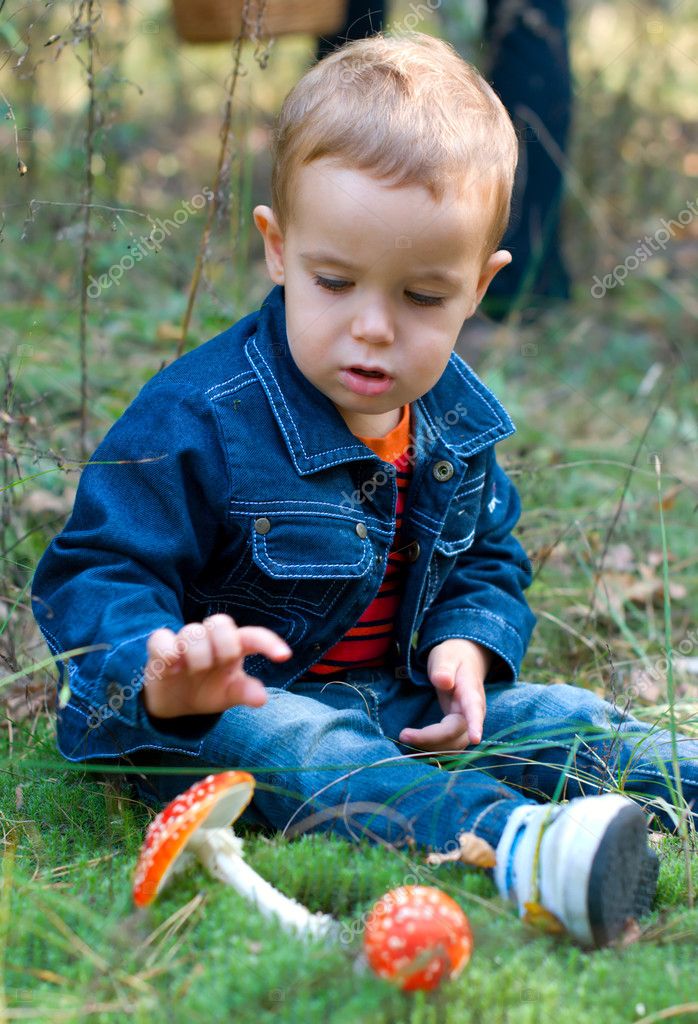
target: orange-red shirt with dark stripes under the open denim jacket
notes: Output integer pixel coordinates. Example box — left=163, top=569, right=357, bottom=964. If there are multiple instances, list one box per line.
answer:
left=306, top=404, right=411, bottom=679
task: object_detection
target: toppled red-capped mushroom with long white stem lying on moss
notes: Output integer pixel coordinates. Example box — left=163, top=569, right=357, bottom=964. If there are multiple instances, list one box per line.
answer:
left=133, top=771, right=339, bottom=937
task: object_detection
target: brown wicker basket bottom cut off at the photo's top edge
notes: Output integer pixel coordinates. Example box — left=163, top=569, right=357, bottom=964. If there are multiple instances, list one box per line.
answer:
left=172, top=0, right=347, bottom=43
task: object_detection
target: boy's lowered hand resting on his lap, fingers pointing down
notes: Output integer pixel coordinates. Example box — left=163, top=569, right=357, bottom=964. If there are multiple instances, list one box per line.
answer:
left=399, top=639, right=493, bottom=751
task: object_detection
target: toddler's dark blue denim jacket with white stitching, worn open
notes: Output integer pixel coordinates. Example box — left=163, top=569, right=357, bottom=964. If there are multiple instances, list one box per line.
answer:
left=33, top=287, right=535, bottom=761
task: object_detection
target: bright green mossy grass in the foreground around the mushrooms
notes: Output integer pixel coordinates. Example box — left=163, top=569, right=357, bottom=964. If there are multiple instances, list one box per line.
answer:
left=0, top=717, right=698, bottom=1024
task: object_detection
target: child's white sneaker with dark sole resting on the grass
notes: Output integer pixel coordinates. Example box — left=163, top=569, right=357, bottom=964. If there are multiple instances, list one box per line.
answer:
left=494, top=794, right=659, bottom=946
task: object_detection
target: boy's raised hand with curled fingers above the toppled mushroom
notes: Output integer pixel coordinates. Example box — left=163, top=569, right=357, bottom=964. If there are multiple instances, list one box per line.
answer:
left=142, top=614, right=292, bottom=718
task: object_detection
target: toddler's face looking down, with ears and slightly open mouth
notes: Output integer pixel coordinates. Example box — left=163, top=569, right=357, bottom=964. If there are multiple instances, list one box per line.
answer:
left=254, top=158, right=511, bottom=437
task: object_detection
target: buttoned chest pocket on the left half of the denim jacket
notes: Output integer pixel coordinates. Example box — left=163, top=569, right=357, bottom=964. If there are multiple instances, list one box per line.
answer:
left=226, top=512, right=374, bottom=614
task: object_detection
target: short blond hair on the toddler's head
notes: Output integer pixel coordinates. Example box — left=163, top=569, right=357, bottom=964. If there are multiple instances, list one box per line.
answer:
left=271, top=33, right=518, bottom=259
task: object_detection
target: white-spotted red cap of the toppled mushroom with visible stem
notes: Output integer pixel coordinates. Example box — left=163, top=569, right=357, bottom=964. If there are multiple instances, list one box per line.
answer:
left=133, top=771, right=255, bottom=906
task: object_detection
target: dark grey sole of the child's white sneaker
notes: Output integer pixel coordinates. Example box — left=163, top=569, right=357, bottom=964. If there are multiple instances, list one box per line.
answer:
left=587, top=805, right=659, bottom=946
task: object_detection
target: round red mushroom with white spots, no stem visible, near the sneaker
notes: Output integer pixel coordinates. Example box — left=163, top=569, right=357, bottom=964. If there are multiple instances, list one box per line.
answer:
left=363, top=886, right=473, bottom=991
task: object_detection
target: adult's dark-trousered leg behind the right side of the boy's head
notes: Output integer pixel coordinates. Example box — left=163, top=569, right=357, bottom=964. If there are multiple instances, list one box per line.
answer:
left=482, top=0, right=572, bottom=319
